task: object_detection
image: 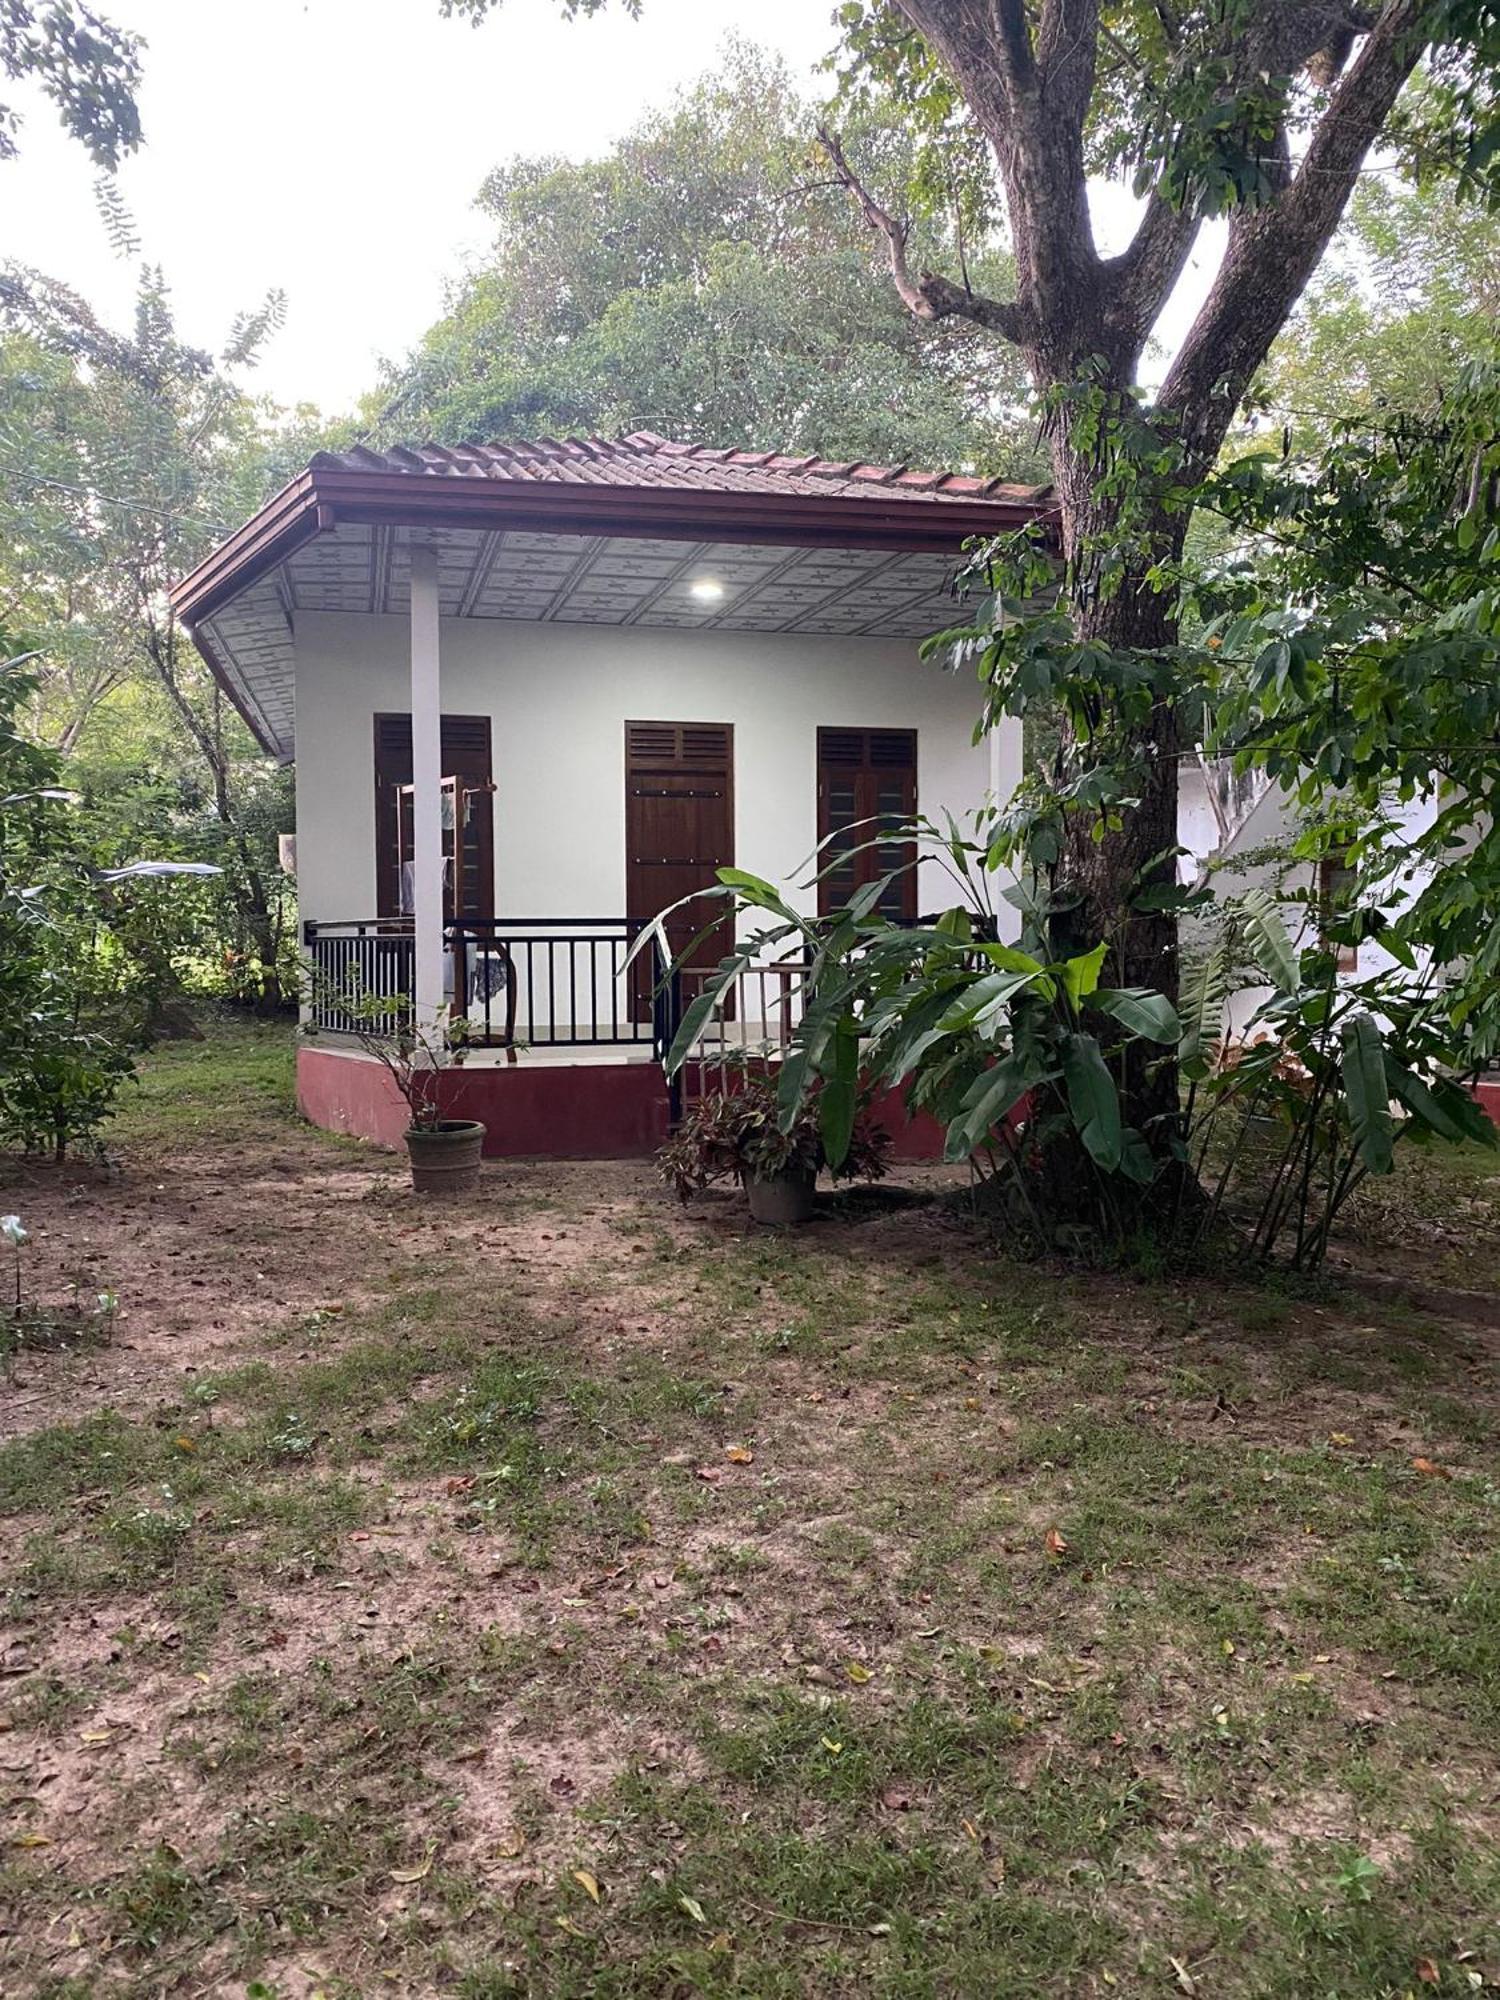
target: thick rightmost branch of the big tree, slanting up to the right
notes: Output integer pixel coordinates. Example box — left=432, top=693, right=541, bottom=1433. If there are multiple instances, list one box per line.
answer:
left=1160, top=0, right=1432, bottom=468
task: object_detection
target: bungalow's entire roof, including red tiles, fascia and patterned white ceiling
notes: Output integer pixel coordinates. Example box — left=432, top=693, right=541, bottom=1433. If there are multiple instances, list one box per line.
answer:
left=172, top=430, right=1052, bottom=756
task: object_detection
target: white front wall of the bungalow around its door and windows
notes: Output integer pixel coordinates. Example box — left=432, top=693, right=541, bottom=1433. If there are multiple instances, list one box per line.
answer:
left=296, top=612, right=1020, bottom=920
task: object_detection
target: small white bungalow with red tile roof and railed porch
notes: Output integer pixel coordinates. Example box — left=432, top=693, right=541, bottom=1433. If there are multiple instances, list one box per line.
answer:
left=172, top=432, right=1044, bottom=1156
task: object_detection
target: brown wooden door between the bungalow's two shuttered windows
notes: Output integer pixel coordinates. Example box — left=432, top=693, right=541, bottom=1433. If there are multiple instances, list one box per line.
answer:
left=626, top=722, right=734, bottom=1006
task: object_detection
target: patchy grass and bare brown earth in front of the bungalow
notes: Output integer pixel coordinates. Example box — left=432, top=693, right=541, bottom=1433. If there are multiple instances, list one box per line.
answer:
left=0, top=1028, right=1500, bottom=2000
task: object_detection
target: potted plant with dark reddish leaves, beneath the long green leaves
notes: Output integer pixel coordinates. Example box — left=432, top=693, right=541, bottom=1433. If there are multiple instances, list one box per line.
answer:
left=656, top=1072, right=890, bottom=1226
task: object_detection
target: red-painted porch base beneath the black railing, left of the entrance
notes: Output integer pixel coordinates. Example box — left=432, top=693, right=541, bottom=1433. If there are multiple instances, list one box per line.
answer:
left=296, top=1048, right=668, bottom=1160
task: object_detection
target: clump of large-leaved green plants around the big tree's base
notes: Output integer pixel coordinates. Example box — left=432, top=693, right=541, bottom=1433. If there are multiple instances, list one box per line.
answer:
left=632, top=814, right=1496, bottom=1266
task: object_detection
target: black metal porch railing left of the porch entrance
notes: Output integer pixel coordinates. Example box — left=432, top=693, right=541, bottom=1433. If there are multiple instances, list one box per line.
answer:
left=302, top=916, right=682, bottom=1054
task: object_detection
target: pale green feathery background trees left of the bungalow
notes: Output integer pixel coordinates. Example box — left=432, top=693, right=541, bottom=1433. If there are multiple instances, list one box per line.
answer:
left=0, top=248, right=302, bottom=1002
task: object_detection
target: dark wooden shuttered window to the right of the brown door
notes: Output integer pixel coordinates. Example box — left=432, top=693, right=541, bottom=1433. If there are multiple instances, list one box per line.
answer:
left=818, top=728, right=916, bottom=918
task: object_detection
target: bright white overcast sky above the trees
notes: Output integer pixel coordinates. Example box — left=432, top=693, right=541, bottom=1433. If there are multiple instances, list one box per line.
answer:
left=0, top=0, right=1212, bottom=414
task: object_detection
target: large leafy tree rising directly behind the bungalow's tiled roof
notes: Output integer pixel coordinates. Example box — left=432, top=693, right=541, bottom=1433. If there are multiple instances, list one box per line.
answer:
left=378, top=42, right=1044, bottom=478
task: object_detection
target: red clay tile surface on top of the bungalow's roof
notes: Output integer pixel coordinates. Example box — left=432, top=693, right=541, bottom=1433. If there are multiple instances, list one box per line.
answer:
left=310, top=430, right=1048, bottom=506
